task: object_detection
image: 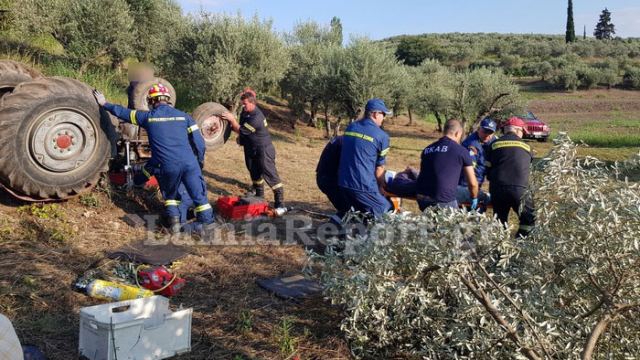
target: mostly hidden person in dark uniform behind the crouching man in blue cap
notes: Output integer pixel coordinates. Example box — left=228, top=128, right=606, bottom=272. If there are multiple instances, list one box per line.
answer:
left=316, top=136, right=349, bottom=224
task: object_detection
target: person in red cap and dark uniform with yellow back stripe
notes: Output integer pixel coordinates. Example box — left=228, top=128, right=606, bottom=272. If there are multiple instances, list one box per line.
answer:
left=486, top=117, right=536, bottom=236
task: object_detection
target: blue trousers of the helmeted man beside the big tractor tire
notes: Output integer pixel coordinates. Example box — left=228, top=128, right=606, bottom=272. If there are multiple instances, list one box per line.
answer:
left=158, top=158, right=213, bottom=224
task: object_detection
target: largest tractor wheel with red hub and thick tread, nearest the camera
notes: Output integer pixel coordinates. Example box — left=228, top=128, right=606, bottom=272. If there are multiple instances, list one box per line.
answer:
left=0, top=77, right=110, bottom=201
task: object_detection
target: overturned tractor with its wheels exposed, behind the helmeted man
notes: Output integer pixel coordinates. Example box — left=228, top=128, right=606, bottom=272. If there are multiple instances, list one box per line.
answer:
left=0, top=60, right=230, bottom=201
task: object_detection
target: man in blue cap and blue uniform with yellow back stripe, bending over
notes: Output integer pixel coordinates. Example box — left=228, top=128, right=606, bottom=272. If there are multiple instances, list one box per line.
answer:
left=338, top=98, right=391, bottom=217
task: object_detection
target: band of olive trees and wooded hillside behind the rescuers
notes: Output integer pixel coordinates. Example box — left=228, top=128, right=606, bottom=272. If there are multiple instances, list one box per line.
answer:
left=0, top=0, right=640, bottom=135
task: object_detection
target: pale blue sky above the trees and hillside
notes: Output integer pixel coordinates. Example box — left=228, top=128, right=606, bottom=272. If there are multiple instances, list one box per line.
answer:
left=177, top=0, right=640, bottom=40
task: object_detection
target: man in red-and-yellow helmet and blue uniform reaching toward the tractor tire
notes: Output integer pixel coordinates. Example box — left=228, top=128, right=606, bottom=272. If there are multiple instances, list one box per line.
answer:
left=94, top=84, right=213, bottom=233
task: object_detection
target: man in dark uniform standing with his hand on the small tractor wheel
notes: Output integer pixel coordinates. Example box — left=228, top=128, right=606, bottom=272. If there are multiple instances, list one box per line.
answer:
left=221, top=88, right=285, bottom=209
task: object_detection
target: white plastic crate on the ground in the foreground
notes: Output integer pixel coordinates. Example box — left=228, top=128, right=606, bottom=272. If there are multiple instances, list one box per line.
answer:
left=79, top=296, right=193, bottom=360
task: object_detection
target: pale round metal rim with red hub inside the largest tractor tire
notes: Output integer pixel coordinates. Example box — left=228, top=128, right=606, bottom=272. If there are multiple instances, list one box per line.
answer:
left=30, top=109, right=97, bottom=173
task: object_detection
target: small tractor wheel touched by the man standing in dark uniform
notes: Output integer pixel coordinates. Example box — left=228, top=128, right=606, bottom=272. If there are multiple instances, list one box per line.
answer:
left=193, top=102, right=231, bottom=150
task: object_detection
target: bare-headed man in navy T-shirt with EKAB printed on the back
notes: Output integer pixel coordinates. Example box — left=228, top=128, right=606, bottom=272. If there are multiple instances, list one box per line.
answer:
left=416, top=119, right=478, bottom=211
